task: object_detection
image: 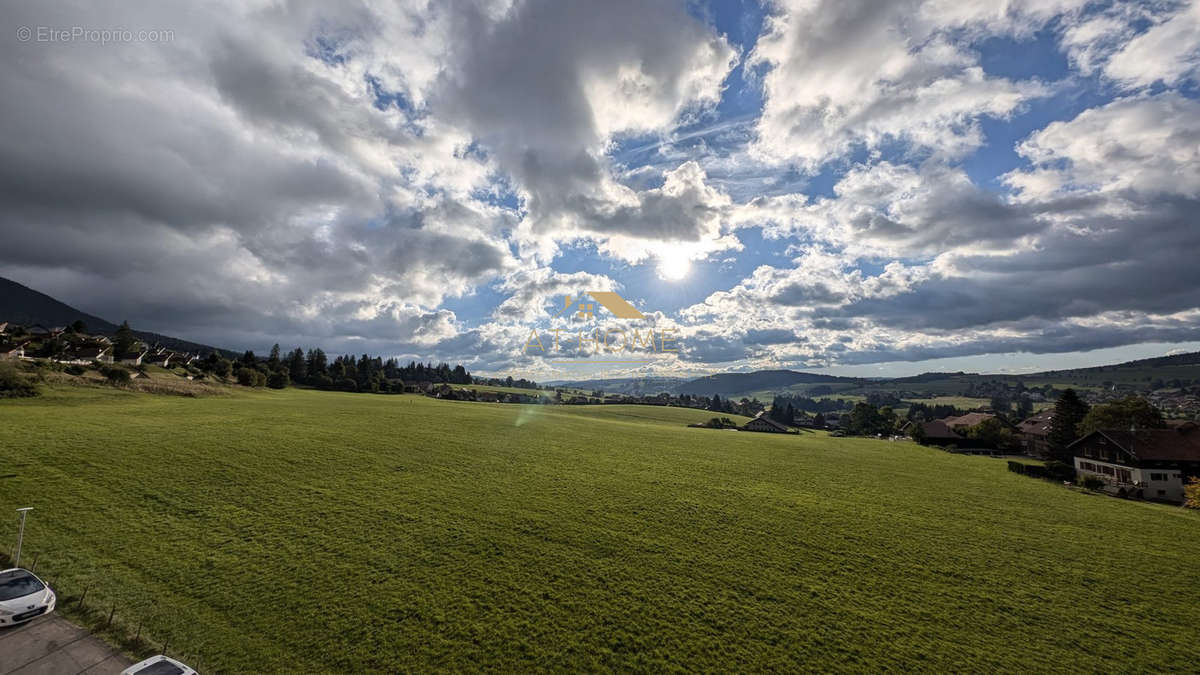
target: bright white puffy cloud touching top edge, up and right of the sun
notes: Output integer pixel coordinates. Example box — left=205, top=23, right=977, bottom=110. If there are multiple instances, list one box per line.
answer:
left=751, top=0, right=1067, bottom=165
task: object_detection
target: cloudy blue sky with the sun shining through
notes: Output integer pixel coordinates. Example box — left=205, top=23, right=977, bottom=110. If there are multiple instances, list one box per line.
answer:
left=0, top=0, right=1200, bottom=380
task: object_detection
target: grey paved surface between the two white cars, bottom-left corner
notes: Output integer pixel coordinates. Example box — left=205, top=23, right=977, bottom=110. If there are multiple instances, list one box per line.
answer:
left=0, top=615, right=130, bottom=675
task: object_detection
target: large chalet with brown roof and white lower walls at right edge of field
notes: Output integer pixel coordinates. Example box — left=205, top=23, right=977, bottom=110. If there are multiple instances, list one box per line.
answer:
left=1069, top=425, right=1200, bottom=502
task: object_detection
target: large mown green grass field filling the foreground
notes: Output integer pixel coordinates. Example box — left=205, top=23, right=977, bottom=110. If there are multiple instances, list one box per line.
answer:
left=0, top=388, right=1200, bottom=673
